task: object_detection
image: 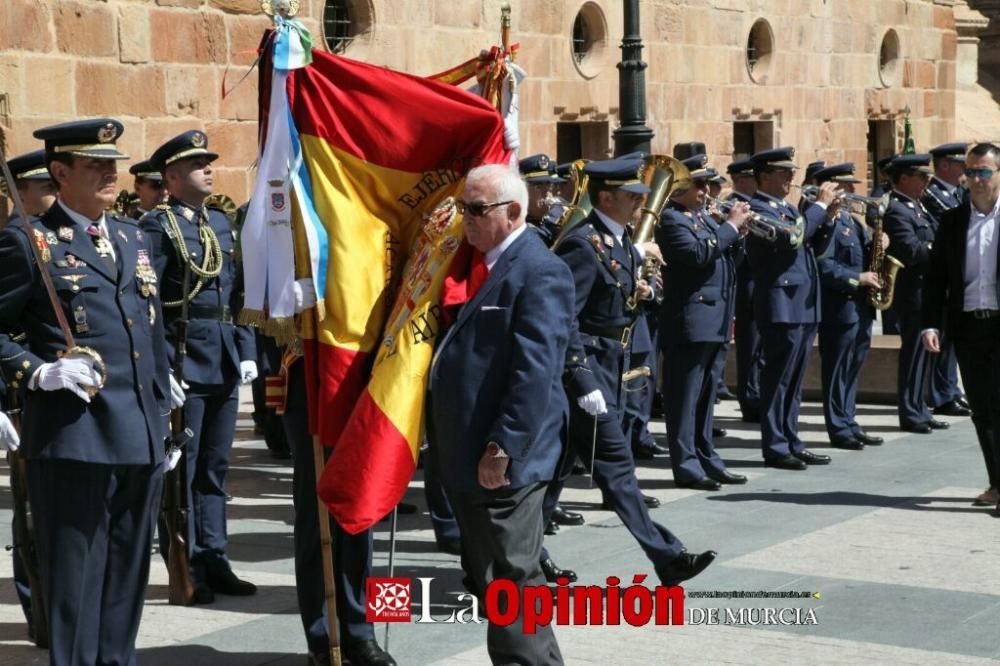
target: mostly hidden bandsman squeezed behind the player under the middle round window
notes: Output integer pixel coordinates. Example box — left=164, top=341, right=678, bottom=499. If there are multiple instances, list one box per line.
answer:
left=726, top=160, right=760, bottom=423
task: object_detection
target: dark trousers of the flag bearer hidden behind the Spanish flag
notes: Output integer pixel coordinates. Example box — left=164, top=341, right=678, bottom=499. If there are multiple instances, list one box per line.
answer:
left=283, top=362, right=375, bottom=654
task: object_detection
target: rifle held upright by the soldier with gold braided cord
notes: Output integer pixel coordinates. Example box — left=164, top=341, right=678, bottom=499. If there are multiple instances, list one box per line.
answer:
left=161, top=262, right=194, bottom=606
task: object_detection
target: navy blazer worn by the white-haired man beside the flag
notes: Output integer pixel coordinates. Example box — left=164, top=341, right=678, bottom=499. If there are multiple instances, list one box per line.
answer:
left=428, top=229, right=573, bottom=493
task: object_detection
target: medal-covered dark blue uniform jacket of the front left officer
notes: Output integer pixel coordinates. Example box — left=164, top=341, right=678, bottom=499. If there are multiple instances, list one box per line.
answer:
left=0, top=204, right=170, bottom=465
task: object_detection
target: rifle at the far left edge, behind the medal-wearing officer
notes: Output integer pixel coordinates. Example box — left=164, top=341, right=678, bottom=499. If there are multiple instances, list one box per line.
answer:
left=6, top=387, right=49, bottom=648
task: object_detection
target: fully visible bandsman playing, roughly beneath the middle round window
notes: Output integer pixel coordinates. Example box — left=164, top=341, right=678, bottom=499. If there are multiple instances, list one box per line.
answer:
left=747, top=148, right=837, bottom=470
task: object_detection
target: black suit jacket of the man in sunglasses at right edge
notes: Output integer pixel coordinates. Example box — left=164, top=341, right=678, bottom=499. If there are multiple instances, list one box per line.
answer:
left=920, top=201, right=1000, bottom=339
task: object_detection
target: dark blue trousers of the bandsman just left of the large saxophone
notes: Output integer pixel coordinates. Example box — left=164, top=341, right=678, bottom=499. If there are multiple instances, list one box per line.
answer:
left=819, top=317, right=872, bottom=441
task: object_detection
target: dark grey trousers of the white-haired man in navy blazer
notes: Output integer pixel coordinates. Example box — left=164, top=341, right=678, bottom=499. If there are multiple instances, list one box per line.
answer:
left=453, top=482, right=563, bottom=665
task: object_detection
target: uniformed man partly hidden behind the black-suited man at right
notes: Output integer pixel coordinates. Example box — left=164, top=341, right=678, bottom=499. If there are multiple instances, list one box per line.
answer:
left=920, top=143, right=972, bottom=416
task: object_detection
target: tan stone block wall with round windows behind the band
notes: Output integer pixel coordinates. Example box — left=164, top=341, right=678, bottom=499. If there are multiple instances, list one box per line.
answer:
left=0, top=0, right=968, bottom=199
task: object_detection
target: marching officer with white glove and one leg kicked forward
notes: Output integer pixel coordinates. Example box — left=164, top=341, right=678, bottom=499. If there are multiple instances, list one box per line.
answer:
left=555, top=159, right=715, bottom=585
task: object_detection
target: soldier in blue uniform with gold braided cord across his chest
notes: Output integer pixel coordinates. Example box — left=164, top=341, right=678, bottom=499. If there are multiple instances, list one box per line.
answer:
left=140, top=130, right=257, bottom=604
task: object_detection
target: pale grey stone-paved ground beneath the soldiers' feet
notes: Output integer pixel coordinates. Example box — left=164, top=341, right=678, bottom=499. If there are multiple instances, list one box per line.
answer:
left=0, top=386, right=1000, bottom=666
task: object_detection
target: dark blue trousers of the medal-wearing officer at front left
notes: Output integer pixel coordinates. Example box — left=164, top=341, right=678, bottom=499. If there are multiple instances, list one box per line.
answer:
left=28, top=460, right=163, bottom=666
